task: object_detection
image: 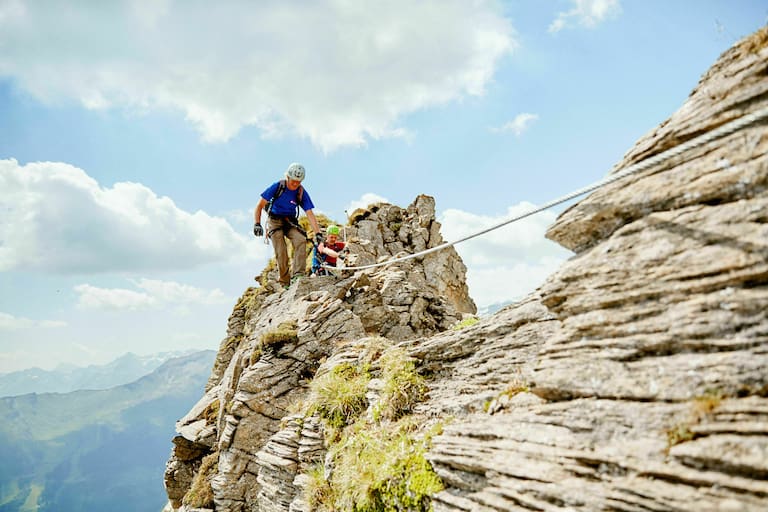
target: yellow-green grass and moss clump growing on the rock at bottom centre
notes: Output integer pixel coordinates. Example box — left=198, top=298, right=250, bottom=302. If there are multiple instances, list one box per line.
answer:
left=306, top=338, right=443, bottom=512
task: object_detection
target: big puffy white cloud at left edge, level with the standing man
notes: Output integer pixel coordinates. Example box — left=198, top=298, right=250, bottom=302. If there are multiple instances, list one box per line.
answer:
left=0, top=159, right=264, bottom=273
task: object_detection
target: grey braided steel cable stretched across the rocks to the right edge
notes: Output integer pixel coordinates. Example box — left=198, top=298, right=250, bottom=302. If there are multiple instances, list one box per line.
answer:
left=330, top=107, right=768, bottom=270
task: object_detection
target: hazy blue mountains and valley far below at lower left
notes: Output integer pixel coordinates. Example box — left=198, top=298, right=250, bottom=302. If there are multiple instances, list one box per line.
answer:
left=0, top=350, right=216, bottom=512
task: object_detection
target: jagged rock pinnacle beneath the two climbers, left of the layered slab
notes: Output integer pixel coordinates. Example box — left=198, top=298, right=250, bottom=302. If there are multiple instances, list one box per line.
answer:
left=165, top=196, right=476, bottom=511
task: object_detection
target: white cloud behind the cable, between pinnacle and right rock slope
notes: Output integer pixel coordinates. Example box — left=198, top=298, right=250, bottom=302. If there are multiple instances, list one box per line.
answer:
left=439, top=202, right=571, bottom=309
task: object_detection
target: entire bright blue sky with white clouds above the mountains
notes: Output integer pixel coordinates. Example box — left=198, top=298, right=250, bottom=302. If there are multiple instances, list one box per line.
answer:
left=0, top=0, right=768, bottom=372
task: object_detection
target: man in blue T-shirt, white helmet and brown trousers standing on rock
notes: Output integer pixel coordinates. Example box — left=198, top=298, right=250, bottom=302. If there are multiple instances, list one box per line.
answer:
left=253, top=163, right=323, bottom=288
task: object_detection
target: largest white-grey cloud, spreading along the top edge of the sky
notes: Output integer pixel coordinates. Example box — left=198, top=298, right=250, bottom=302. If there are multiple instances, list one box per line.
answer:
left=0, top=0, right=517, bottom=151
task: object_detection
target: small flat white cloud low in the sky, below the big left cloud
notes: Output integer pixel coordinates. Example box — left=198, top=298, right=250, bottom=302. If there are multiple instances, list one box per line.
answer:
left=75, top=279, right=230, bottom=311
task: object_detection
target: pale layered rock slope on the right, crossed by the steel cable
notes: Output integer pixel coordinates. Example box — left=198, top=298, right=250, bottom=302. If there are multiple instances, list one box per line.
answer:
left=411, top=30, right=768, bottom=511
